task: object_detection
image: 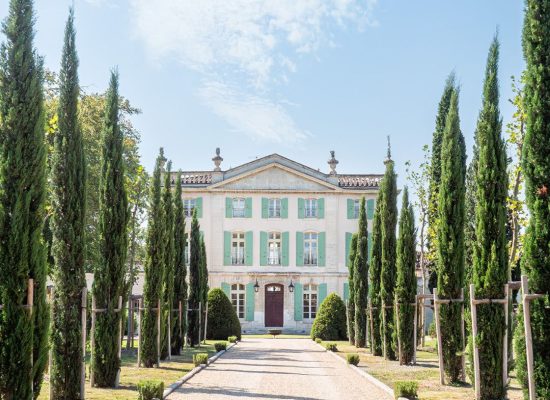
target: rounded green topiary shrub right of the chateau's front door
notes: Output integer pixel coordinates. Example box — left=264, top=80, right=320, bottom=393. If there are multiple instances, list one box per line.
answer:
left=311, top=293, right=347, bottom=340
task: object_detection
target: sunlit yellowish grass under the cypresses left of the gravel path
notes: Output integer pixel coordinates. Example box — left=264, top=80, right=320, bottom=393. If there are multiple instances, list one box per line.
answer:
left=38, top=340, right=216, bottom=400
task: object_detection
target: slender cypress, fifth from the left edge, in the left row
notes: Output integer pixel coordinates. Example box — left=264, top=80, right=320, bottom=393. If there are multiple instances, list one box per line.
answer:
left=160, top=161, right=176, bottom=360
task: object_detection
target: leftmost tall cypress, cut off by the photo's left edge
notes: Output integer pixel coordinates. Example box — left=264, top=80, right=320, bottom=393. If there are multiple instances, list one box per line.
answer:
left=0, top=0, right=49, bottom=400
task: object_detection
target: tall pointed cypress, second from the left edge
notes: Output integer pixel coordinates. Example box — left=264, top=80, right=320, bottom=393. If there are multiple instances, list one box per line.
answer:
left=50, top=10, right=86, bottom=400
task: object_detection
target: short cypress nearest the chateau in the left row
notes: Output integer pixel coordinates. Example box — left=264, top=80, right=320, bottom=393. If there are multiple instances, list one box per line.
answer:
left=187, top=209, right=202, bottom=346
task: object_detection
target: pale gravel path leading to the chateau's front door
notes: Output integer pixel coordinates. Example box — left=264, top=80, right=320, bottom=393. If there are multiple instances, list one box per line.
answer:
left=168, top=339, right=391, bottom=400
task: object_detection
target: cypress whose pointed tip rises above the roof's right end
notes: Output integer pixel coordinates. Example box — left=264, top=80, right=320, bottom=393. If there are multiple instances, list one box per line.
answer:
left=380, top=139, right=397, bottom=360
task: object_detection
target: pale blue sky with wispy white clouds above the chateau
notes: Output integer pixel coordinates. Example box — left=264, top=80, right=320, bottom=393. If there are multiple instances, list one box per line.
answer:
left=0, top=0, right=524, bottom=194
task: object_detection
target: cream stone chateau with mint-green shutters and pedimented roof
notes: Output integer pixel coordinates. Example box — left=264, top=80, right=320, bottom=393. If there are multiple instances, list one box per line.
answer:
left=173, top=149, right=382, bottom=333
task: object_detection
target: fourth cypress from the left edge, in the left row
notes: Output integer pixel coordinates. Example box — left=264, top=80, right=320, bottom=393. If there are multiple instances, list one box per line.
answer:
left=139, top=147, right=165, bottom=368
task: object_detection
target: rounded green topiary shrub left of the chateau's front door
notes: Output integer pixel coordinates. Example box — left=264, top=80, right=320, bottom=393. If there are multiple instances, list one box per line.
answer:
left=206, top=289, right=241, bottom=340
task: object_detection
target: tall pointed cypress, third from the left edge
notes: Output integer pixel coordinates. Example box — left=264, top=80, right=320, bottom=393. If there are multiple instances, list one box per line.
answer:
left=92, top=71, right=128, bottom=387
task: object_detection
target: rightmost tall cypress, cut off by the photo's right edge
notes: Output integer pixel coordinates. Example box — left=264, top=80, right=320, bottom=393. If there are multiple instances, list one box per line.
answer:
left=518, top=0, right=550, bottom=399
